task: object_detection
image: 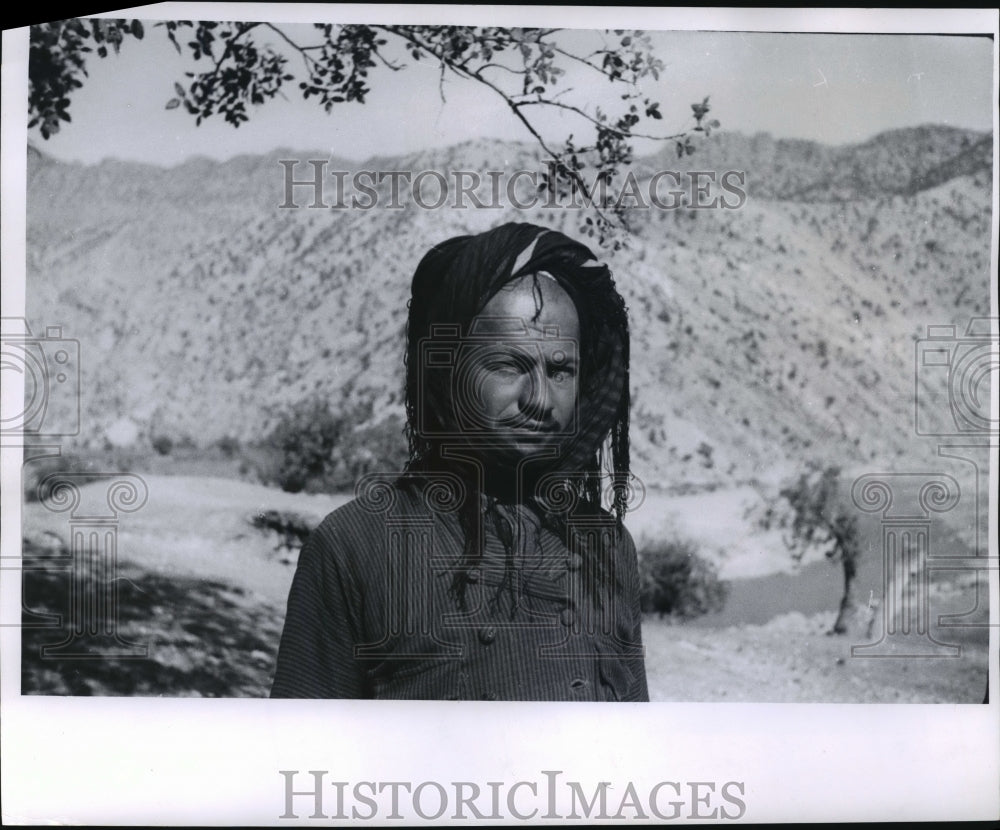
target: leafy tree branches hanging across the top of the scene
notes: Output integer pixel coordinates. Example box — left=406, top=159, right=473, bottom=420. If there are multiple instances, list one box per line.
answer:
left=29, top=19, right=719, bottom=246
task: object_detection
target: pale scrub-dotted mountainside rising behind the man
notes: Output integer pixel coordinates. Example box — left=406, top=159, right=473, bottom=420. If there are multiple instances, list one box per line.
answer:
left=27, top=126, right=992, bottom=486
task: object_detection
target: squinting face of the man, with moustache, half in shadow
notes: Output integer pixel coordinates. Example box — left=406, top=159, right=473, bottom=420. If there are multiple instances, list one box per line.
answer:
left=459, top=274, right=580, bottom=458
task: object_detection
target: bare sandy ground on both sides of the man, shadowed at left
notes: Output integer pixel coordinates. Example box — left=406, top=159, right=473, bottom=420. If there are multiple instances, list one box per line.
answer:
left=22, top=475, right=987, bottom=703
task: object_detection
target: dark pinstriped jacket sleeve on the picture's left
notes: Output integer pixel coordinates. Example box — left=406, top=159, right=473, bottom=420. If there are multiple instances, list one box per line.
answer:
left=271, top=521, right=371, bottom=698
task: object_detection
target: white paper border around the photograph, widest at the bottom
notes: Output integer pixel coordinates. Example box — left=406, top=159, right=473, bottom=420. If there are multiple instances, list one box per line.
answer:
left=0, top=3, right=1000, bottom=825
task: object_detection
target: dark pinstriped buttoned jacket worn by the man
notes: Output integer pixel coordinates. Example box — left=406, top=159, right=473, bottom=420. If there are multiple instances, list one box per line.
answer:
left=271, top=474, right=649, bottom=701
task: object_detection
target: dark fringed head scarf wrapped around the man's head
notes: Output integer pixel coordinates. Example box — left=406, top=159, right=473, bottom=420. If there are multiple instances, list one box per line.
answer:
left=406, top=223, right=629, bottom=488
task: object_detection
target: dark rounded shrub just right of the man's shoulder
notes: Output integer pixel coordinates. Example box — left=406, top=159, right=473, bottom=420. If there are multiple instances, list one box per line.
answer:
left=639, top=540, right=729, bottom=619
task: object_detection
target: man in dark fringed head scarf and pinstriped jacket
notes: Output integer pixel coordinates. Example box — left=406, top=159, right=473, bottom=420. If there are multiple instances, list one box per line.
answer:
left=271, top=223, right=648, bottom=701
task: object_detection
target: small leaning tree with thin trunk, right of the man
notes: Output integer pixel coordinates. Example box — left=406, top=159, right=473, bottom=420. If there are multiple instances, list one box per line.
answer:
left=769, top=462, right=861, bottom=634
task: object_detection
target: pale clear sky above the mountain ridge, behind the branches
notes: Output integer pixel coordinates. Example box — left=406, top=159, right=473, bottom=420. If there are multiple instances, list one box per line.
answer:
left=15, top=12, right=995, bottom=166
